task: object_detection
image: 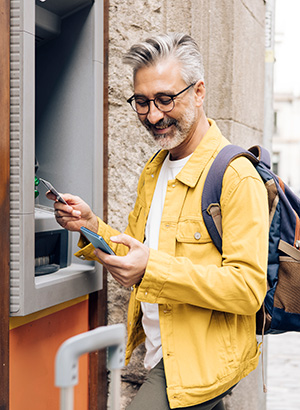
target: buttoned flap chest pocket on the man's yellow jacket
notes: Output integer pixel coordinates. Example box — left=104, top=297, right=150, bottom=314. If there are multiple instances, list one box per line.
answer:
left=176, top=219, right=212, bottom=260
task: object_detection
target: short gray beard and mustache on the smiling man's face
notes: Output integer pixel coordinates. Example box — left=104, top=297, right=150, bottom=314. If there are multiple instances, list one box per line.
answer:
left=141, top=102, right=197, bottom=150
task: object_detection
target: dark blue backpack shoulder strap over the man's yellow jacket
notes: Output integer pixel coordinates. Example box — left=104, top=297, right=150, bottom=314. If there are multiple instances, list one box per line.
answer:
left=201, top=144, right=264, bottom=254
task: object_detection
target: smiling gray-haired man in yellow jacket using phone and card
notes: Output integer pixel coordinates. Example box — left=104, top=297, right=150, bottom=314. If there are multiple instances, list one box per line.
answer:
left=48, top=34, right=268, bottom=410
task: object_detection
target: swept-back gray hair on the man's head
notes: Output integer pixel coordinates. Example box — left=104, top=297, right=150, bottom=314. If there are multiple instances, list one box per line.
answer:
left=123, top=33, right=204, bottom=84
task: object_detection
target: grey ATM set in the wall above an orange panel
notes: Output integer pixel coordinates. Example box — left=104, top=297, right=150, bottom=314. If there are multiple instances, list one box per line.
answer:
left=10, top=0, right=103, bottom=316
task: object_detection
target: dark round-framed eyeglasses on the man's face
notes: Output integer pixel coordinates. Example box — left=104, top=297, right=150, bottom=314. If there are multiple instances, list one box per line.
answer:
left=127, top=83, right=196, bottom=115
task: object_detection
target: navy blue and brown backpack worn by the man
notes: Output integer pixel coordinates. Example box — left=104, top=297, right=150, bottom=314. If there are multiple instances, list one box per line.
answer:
left=202, top=145, right=300, bottom=335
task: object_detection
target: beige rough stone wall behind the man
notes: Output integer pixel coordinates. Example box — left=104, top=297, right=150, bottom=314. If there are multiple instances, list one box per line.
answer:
left=108, top=0, right=265, bottom=410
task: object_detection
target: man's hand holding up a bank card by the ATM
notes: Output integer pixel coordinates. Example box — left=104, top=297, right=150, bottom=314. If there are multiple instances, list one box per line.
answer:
left=46, top=191, right=98, bottom=232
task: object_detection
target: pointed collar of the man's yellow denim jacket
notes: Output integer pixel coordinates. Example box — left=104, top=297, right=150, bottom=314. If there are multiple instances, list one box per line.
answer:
left=148, top=119, right=223, bottom=188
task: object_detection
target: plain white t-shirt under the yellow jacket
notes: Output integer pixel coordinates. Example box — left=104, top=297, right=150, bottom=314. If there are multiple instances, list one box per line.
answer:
left=141, top=154, right=191, bottom=369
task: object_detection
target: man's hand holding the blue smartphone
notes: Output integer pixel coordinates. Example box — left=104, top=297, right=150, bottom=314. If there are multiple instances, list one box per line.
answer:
left=95, top=234, right=149, bottom=287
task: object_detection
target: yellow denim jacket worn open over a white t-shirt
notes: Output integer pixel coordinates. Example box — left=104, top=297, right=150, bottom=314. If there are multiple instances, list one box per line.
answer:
left=77, top=120, right=268, bottom=408
